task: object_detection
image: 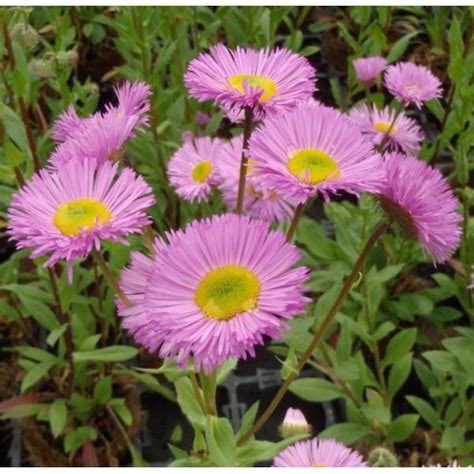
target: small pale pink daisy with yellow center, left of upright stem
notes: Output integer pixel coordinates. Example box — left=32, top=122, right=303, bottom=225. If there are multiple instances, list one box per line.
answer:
left=168, top=137, right=224, bottom=202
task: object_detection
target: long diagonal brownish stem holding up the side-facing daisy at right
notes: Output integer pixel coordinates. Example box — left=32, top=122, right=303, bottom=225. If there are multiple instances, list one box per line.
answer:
left=237, top=223, right=388, bottom=446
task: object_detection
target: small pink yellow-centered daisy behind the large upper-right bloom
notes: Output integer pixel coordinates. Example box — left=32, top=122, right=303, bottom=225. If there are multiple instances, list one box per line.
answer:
left=349, top=104, right=425, bottom=155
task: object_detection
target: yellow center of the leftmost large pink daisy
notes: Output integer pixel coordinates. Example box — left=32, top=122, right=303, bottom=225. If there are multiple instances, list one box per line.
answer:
left=53, top=198, right=110, bottom=235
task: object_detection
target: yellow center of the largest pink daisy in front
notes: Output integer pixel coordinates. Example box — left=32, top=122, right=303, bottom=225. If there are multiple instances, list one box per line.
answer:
left=194, top=265, right=260, bottom=320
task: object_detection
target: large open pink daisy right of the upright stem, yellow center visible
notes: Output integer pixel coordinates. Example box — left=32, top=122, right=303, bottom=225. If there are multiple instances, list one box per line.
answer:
left=249, top=102, right=385, bottom=203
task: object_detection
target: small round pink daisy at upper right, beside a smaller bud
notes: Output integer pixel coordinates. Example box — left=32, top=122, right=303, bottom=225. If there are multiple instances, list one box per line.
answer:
left=384, top=62, right=443, bottom=109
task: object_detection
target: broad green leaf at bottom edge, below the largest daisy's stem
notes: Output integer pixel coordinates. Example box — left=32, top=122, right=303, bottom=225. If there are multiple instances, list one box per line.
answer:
left=205, top=416, right=236, bottom=467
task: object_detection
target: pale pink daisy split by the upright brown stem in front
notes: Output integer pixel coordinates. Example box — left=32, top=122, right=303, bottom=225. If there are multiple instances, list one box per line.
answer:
left=216, top=136, right=294, bottom=222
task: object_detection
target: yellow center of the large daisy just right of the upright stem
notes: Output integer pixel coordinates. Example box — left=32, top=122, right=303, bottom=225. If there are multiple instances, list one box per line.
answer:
left=287, top=148, right=341, bottom=184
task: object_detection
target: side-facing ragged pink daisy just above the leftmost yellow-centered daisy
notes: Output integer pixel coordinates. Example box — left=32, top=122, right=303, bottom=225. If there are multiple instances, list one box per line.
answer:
left=49, top=82, right=150, bottom=167
